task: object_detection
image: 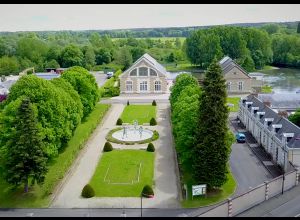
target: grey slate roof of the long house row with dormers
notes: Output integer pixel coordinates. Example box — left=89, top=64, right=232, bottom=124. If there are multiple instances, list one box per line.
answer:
left=244, top=95, right=300, bottom=148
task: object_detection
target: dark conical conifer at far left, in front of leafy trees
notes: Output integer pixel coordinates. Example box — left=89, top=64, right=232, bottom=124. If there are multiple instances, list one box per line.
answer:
left=3, top=98, right=47, bottom=192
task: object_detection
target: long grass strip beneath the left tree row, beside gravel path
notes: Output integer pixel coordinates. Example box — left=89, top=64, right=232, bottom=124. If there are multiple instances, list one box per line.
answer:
left=0, top=104, right=110, bottom=208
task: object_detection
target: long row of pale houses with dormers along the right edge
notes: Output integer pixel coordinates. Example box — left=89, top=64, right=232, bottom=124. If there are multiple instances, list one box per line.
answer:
left=238, top=95, right=300, bottom=171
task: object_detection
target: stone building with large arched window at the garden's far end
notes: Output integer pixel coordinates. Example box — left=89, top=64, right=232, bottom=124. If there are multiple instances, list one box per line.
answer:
left=119, top=53, right=168, bottom=94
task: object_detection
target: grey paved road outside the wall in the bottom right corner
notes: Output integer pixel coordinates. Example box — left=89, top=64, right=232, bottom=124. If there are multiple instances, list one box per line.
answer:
left=238, top=185, right=300, bottom=217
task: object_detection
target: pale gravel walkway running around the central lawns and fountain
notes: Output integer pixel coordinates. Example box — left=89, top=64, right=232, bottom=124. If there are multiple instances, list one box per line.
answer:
left=50, top=104, right=179, bottom=208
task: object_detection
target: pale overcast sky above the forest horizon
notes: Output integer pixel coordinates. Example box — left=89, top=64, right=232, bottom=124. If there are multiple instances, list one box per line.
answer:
left=0, top=4, right=300, bottom=31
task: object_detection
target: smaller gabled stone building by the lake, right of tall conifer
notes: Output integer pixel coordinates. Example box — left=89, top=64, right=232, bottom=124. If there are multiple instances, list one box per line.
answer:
left=219, top=56, right=257, bottom=94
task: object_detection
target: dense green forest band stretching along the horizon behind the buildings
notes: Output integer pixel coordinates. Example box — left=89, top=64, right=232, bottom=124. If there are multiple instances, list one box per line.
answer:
left=0, top=22, right=300, bottom=75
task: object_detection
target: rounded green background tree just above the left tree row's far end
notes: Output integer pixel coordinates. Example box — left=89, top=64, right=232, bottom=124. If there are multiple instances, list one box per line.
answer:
left=61, top=44, right=83, bottom=67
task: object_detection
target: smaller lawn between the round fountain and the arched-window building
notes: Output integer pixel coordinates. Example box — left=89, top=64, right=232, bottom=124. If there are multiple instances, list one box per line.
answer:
left=121, top=105, right=156, bottom=124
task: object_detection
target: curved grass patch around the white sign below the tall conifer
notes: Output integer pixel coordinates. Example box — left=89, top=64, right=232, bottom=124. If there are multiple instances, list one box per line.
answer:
left=181, top=168, right=236, bottom=208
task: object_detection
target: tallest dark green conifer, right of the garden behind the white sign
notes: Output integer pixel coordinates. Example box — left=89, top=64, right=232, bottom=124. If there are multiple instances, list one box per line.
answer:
left=192, top=59, right=230, bottom=188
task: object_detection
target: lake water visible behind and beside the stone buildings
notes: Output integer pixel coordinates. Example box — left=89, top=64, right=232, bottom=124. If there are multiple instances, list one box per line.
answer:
left=167, top=68, right=300, bottom=95
